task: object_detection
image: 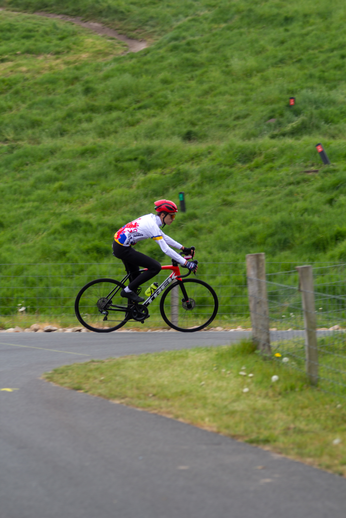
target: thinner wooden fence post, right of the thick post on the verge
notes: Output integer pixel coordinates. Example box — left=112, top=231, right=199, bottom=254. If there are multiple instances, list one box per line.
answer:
left=296, top=266, right=318, bottom=385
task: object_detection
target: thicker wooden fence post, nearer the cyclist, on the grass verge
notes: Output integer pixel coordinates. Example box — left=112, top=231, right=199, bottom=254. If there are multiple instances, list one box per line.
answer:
left=246, top=254, right=271, bottom=354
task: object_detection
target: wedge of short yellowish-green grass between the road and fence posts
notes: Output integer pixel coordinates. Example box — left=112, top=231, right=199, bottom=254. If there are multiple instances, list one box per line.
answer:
left=45, top=341, right=346, bottom=476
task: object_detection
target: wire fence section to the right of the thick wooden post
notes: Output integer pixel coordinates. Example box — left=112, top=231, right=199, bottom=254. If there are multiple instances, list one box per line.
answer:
left=266, top=264, right=346, bottom=396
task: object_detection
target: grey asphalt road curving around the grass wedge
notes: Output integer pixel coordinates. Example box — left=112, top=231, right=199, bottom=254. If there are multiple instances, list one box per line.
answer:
left=0, top=332, right=346, bottom=518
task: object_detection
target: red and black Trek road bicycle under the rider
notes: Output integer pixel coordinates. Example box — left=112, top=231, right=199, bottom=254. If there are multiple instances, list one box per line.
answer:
left=75, top=257, right=219, bottom=333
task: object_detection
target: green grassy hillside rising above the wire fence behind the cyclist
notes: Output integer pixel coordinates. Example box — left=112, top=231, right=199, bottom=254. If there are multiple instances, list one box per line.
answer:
left=0, top=0, right=346, bottom=263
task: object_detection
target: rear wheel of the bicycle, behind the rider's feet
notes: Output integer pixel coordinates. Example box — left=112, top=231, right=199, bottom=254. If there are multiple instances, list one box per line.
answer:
left=74, top=279, right=129, bottom=333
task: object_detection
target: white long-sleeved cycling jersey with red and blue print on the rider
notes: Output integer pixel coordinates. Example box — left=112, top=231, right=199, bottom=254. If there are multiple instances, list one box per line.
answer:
left=114, top=214, right=186, bottom=265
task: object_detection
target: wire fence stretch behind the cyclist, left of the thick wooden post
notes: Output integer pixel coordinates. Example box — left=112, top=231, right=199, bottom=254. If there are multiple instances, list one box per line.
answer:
left=0, top=261, right=250, bottom=328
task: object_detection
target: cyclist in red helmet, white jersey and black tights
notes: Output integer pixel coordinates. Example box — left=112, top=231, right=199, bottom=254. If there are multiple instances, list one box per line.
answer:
left=113, top=200, right=197, bottom=302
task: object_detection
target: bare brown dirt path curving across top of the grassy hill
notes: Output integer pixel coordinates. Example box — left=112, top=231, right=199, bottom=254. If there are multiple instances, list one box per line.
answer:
left=0, top=8, right=148, bottom=52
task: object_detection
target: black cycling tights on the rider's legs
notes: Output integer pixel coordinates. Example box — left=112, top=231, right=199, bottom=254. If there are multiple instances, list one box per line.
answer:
left=113, top=241, right=161, bottom=291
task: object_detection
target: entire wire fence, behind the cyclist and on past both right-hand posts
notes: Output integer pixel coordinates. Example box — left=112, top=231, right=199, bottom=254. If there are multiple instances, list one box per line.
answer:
left=0, top=262, right=346, bottom=395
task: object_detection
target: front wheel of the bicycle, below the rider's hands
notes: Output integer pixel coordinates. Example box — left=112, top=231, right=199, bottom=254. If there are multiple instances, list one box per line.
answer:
left=160, top=279, right=219, bottom=333
